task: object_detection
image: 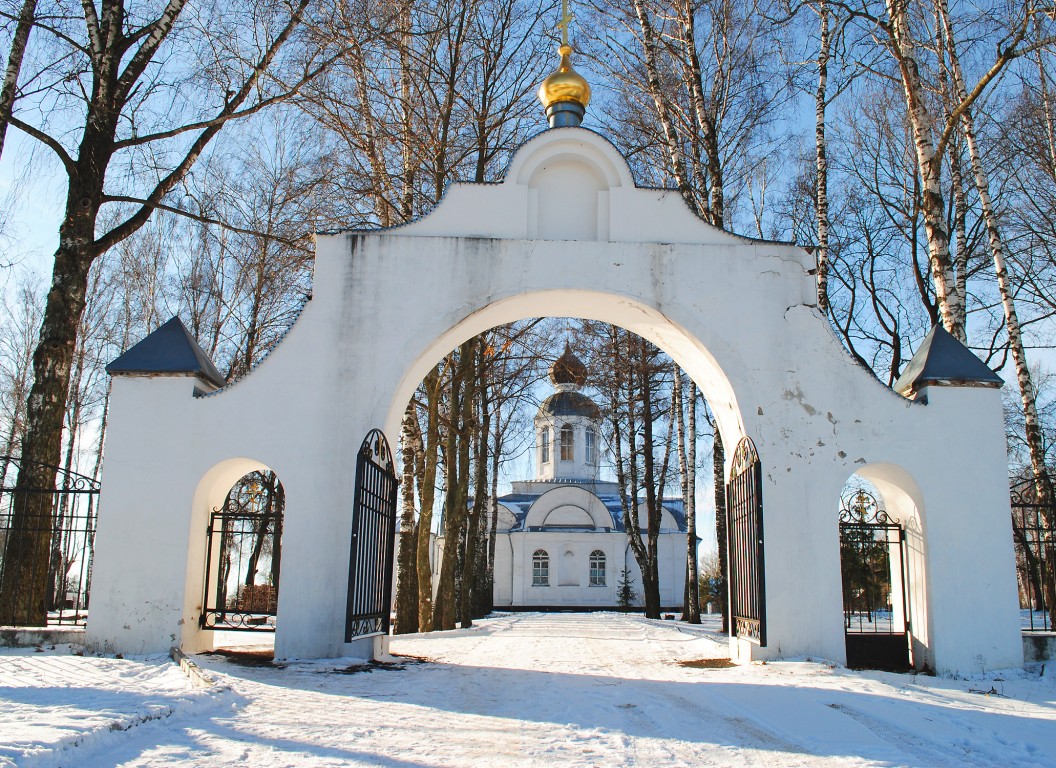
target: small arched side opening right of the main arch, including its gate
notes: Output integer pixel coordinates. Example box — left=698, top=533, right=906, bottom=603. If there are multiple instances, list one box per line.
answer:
left=838, top=465, right=931, bottom=671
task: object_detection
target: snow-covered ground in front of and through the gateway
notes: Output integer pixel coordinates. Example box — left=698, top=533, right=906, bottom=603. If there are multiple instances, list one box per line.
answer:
left=0, top=614, right=1056, bottom=768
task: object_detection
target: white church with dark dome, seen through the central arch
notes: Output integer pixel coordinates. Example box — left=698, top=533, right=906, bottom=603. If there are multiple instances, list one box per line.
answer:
left=445, top=344, right=686, bottom=611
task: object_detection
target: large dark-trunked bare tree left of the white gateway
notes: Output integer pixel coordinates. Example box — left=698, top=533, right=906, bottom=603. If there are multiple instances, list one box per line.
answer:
left=0, top=0, right=337, bottom=624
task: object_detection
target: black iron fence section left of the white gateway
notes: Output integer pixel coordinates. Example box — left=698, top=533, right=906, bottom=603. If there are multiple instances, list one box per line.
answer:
left=0, top=456, right=99, bottom=626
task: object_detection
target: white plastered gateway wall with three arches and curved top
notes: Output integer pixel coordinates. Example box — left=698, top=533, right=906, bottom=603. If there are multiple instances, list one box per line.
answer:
left=88, top=128, right=1023, bottom=672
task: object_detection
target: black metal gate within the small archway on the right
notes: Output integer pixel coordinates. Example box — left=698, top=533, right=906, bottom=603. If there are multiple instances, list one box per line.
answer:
left=840, top=490, right=910, bottom=672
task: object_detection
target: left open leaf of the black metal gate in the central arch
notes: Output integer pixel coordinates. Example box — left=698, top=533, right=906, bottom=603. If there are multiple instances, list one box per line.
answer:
left=344, top=429, right=398, bottom=642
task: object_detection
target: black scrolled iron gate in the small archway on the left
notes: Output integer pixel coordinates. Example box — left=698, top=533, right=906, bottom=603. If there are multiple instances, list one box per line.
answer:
left=199, top=472, right=285, bottom=632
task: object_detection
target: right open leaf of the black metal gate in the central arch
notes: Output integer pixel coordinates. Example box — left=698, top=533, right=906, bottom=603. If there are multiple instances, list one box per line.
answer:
left=727, top=437, right=767, bottom=648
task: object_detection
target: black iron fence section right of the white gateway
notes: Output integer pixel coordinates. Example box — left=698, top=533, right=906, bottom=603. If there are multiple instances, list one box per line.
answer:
left=1011, top=481, right=1056, bottom=632
